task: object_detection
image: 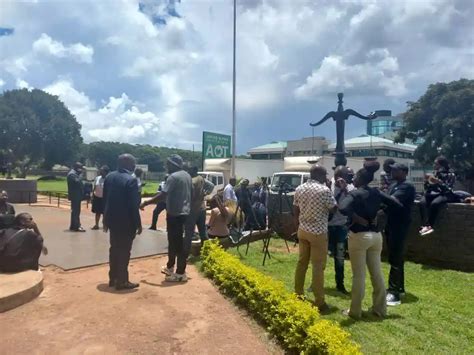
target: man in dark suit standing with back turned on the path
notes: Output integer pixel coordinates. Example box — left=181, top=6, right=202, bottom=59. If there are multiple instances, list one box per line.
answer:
left=103, top=154, right=142, bottom=290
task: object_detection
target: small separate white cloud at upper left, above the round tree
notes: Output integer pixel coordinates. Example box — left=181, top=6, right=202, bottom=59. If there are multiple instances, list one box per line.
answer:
left=33, top=33, right=94, bottom=64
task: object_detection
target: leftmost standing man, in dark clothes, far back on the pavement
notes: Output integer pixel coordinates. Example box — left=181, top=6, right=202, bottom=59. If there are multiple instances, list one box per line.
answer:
left=67, top=163, right=85, bottom=232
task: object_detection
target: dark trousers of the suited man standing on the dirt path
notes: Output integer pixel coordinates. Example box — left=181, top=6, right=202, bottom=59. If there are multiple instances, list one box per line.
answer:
left=109, top=229, right=135, bottom=284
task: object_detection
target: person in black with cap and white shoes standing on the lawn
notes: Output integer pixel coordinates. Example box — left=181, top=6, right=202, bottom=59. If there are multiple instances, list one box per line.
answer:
left=385, top=163, right=415, bottom=306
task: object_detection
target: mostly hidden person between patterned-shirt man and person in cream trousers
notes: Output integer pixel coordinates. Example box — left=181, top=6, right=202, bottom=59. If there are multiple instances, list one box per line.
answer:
left=328, top=166, right=354, bottom=295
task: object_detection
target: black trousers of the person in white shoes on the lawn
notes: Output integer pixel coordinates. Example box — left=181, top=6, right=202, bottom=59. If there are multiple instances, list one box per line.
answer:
left=385, top=220, right=410, bottom=295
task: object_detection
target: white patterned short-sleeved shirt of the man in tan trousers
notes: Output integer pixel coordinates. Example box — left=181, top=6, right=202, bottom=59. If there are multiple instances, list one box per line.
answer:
left=293, top=179, right=336, bottom=234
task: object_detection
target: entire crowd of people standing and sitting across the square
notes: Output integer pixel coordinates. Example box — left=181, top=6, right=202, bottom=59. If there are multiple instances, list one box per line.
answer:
left=0, top=154, right=470, bottom=318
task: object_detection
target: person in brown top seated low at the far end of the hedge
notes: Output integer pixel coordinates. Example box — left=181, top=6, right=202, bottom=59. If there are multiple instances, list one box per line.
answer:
left=207, top=195, right=237, bottom=238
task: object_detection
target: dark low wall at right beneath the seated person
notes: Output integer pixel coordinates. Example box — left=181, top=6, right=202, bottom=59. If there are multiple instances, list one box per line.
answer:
left=396, top=203, right=474, bottom=272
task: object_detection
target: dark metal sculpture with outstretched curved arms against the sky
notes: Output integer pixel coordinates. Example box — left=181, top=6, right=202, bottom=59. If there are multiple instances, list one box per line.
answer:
left=309, top=92, right=377, bottom=166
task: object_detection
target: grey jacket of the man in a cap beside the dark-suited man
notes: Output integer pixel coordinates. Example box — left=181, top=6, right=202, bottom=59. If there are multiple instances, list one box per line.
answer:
left=163, top=170, right=192, bottom=217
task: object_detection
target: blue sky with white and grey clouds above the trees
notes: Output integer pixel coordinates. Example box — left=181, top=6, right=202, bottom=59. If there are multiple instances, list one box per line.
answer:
left=0, top=0, right=474, bottom=153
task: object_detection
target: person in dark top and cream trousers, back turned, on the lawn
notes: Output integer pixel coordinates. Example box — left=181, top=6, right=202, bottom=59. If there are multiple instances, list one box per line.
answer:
left=339, top=162, right=402, bottom=318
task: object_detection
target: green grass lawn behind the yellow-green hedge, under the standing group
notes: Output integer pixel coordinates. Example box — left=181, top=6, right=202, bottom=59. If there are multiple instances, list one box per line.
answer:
left=229, top=239, right=474, bottom=354
